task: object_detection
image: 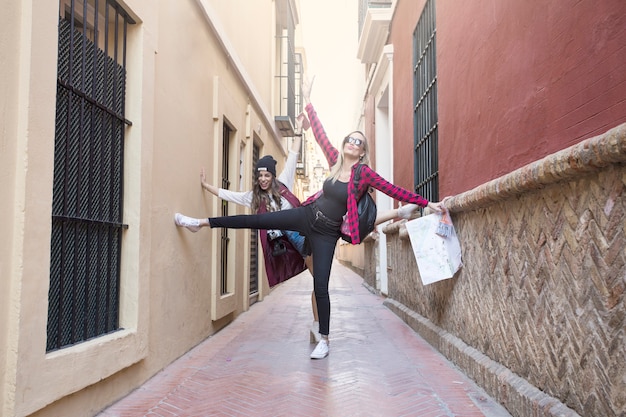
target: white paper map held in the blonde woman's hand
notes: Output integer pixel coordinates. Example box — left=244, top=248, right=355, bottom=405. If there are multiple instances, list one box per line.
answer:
left=406, top=213, right=462, bottom=285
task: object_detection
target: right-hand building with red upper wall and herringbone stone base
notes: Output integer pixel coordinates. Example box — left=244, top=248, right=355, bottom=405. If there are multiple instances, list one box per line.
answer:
left=358, top=0, right=626, bottom=416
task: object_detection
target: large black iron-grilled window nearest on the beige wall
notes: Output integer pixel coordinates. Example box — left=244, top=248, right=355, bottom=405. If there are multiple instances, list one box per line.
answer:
left=46, top=0, right=135, bottom=351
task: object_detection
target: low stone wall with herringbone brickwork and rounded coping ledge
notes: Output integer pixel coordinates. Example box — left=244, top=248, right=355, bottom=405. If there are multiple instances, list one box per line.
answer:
left=380, top=124, right=626, bottom=416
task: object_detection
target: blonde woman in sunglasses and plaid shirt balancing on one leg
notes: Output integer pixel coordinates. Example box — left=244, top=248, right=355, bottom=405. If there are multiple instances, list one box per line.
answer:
left=173, top=82, right=442, bottom=359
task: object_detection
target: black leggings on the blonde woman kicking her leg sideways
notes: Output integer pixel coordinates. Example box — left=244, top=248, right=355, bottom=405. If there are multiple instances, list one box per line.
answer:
left=208, top=204, right=340, bottom=336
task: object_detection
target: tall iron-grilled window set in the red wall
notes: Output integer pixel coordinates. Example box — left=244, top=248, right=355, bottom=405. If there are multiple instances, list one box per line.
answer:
left=413, top=0, right=439, bottom=201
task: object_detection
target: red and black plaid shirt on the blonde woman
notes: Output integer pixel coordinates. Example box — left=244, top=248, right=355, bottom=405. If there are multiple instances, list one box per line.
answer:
left=302, top=103, right=428, bottom=245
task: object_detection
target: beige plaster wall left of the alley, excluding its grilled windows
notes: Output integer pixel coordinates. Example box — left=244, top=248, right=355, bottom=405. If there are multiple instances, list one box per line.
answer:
left=0, top=0, right=302, bottom=417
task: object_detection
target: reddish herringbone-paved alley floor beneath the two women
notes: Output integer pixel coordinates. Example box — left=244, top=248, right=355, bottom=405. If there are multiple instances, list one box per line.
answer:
left=98, top=262, right=510, bottom=417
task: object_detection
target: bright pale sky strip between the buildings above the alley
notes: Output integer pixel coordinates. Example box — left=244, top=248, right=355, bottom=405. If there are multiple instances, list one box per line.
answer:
left=299, top=0, right=365, bottom=143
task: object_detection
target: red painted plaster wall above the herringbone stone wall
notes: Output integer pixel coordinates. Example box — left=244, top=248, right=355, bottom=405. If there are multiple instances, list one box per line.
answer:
left=390, top=0, right=626, bottom=197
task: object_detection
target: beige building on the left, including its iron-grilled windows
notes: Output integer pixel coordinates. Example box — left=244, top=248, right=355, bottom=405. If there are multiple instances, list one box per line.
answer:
left=0, top=0, right=309, bottom=416
